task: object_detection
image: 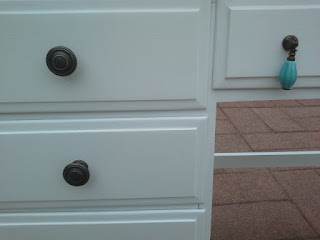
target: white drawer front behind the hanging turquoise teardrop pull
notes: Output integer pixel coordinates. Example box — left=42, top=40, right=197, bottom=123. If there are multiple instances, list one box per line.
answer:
left=213, top=0, right=320, bottom=88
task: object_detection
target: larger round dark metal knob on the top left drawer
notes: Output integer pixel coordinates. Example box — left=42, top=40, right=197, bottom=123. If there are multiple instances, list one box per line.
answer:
left=46, top=47, right=77, bottom=76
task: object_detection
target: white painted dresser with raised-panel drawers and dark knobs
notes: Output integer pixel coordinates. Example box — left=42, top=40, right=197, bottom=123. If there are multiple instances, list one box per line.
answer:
left=0, top=0, right=320, bottom=240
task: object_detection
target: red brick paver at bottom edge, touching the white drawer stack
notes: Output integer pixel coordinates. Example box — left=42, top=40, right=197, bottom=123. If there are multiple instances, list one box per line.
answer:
left=212, top=201, right=318, bottom=240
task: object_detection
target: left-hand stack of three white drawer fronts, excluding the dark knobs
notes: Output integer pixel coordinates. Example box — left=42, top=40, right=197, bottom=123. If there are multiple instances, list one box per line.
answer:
left=0, top=0, right=210, bottom=240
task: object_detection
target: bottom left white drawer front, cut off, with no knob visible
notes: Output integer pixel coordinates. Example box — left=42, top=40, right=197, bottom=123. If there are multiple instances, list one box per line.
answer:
left=0, top=210, right=204, bottom=240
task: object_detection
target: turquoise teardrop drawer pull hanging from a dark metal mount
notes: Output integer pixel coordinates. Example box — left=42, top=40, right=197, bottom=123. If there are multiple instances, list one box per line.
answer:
left=279, top=35, right=299, bottom=90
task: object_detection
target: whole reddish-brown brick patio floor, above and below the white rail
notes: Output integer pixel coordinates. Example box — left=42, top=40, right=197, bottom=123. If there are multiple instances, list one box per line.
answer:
left=212, top=99, right=320, bottom=240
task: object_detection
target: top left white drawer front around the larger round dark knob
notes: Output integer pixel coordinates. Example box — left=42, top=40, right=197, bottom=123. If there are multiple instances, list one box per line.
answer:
left=0, top=4, right=207, bottom=108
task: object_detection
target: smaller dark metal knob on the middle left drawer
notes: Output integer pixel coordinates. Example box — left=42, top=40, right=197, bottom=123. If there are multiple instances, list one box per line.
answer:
left=63, top=160, right=90, bottom=186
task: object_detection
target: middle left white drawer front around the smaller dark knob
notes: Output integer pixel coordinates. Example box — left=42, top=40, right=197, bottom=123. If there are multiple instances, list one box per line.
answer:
left=0, top=118, right=207, bottom=206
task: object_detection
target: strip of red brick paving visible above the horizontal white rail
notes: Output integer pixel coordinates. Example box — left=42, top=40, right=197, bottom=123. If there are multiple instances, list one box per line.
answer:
left=216, top=99, right=320, bottom=152
